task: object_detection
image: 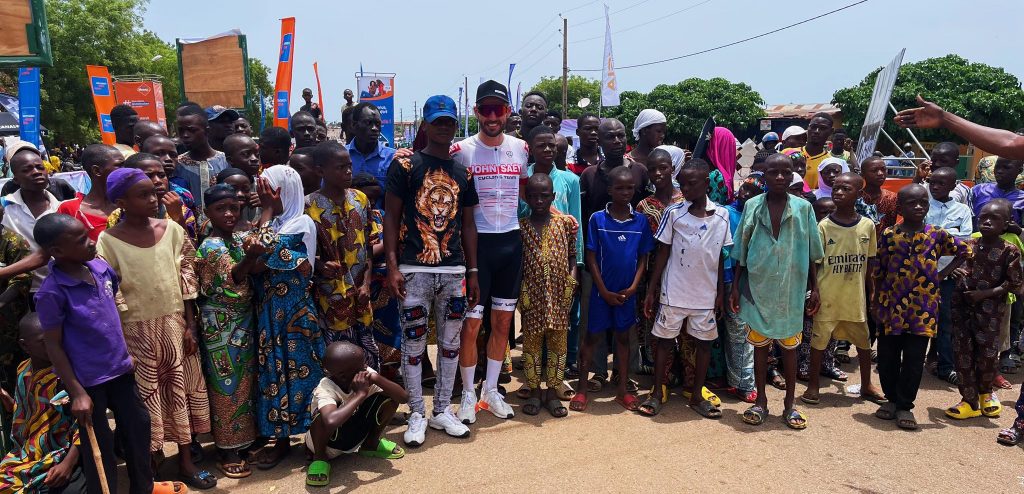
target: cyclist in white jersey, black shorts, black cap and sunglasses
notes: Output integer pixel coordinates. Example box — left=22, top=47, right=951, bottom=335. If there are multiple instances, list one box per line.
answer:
left=452, top=81, right=529, bottom=423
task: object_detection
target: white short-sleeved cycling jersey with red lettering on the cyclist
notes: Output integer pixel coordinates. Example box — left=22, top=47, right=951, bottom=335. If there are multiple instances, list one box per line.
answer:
left=452, top=134, right=529, bottom=234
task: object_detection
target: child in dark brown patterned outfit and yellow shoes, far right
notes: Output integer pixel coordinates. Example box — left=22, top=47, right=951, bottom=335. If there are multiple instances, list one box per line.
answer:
left=946, top=201, right=1024, bottom=419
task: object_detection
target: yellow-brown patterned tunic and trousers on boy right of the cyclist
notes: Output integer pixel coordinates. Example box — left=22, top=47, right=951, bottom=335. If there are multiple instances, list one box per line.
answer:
left=519, top=213, right=580, bottom=389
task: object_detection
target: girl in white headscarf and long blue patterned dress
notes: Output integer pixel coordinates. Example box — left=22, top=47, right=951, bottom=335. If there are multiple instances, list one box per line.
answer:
left=253, top=166, right=326, bottom=469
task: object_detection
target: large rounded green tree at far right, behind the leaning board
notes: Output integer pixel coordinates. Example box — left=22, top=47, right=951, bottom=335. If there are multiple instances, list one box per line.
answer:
left=833, top=54, right=1024, bottom=141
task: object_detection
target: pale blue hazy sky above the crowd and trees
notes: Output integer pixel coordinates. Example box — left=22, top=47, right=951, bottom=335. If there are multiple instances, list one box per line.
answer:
left=143, top=0, right=1024, bottom=121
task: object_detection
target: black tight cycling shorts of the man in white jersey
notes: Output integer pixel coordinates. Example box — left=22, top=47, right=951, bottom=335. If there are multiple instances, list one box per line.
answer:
left=476, top=230, right=522, bottom=312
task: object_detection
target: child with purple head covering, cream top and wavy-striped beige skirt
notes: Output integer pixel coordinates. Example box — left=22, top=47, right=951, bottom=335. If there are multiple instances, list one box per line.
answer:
left=96, top=168, right=217, bottom=489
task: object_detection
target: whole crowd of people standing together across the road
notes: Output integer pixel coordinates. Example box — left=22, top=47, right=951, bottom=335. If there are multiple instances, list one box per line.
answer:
left=0, top=81, right=1024, bottom=494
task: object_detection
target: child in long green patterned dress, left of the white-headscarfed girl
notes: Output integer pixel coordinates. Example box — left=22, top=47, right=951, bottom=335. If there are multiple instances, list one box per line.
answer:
left=196, top=183, right=269, bottom=479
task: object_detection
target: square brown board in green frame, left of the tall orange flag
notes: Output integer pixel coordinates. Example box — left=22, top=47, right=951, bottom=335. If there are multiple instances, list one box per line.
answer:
left=181, top=36, right=246, bottom=108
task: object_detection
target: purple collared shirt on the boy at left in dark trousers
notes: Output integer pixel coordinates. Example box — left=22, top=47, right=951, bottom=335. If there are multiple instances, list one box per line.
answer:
left=36, top=257, right=132, bottom=387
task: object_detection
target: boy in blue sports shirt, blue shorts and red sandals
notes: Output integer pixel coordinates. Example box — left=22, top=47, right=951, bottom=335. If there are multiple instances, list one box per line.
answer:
left=569, top=166, right=654, bottom=412
